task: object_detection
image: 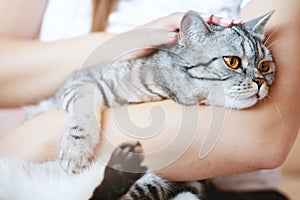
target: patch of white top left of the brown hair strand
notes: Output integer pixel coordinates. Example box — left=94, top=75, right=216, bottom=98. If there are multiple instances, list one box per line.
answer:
left=40, top=0, right=92, bottom=41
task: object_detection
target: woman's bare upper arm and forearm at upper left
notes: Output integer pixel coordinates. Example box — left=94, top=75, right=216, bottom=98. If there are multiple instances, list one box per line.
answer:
left=0, top=0, right=112, bottom=107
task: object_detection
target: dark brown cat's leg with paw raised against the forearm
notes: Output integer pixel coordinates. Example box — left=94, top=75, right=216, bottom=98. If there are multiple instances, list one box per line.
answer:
left=90, top=143, right=147, bottom=200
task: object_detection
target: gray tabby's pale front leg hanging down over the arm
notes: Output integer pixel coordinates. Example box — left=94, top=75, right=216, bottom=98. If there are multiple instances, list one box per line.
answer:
left=59, top=84, right=104, bottom=173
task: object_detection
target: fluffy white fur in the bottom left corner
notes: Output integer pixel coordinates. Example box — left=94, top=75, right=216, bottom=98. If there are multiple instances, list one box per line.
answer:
left=0, top=158, right=104, bottom=200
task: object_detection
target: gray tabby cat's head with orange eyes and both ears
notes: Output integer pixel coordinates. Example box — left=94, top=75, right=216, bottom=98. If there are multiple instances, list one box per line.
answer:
left=179, top=11, right=275, bottom=108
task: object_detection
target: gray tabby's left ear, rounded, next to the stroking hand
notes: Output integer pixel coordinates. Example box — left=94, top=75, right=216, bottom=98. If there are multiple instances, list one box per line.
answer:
left=179, top=10, right=213, bottom=45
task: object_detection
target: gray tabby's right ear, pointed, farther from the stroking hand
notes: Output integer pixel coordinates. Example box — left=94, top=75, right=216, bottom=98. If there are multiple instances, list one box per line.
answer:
left=243, top=11, right=274, bottom=35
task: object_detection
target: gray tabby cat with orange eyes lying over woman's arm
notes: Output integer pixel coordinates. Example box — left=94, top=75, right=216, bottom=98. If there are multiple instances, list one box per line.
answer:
left=18, top=11, right=275, bottom=199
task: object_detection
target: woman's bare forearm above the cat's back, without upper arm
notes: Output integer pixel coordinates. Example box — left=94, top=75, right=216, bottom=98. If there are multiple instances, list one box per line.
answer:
left=0, top=33, right=110, bottom=107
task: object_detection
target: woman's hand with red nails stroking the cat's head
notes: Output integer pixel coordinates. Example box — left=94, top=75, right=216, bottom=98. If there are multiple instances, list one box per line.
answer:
left=122, top=12, right=240, bottom=60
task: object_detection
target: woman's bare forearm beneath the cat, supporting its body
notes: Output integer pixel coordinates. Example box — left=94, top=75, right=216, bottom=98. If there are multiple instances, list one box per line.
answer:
left=0, top=95, right=297, bottom=180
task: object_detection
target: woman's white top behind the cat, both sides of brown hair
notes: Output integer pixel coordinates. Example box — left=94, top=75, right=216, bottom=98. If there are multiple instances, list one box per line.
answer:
left=40, top=0, right=250, bottom=41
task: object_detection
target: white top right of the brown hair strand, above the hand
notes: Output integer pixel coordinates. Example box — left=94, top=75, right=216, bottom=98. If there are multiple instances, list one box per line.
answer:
left=107, top=0, right=241, bottom=33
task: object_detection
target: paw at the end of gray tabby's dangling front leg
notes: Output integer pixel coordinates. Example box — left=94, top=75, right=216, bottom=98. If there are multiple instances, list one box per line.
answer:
left=59, top=146, right=94, bottom=174
